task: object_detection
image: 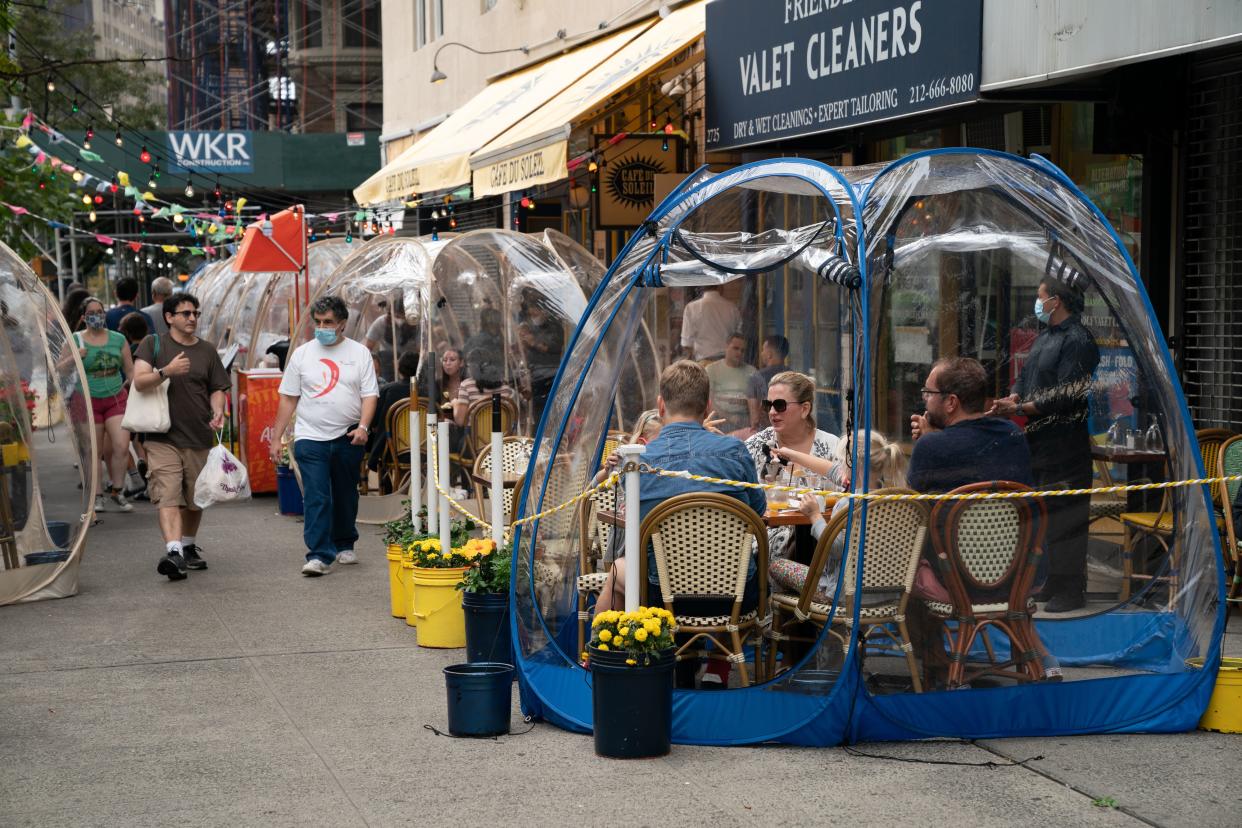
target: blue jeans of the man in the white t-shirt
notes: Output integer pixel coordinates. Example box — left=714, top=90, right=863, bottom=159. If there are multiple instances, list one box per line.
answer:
left=293, top=436, right=365, bottom=564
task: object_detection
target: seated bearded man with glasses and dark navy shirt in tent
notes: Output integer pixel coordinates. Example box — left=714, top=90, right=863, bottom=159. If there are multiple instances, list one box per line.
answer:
left=905, top=356, right=1032, bottom=492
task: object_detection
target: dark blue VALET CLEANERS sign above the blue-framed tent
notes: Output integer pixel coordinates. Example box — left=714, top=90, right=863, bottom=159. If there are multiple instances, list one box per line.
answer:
left=707, top=0, right=982, bottom=149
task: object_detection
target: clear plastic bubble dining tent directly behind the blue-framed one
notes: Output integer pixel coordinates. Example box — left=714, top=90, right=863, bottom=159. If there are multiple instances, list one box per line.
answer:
left=283, top=228, right=660, bottom=436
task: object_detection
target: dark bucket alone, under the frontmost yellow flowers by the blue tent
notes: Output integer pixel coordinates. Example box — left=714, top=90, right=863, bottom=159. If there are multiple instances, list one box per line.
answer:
left=590, top=647, right=677, bottom=758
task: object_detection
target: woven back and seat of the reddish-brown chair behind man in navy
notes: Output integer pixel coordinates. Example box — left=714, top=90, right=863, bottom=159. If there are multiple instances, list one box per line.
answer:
left=932, top=480, right=1047, bottom=613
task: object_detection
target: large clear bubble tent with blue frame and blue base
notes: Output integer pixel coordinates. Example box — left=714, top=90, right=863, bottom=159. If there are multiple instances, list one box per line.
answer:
left=512, top=149, right=1225, bottom=745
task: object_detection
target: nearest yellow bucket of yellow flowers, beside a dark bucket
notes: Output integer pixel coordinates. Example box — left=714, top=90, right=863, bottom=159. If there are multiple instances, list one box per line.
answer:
left=407, top=525, right=496, bottom=647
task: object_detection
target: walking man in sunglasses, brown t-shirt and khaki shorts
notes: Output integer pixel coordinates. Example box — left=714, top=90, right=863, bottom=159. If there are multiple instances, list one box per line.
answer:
left=134, top=293, right=229, bottom=581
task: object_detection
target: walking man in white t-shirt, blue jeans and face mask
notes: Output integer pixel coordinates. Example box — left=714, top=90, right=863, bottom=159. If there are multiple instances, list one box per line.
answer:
left=271, top=297, right=380, bottom=577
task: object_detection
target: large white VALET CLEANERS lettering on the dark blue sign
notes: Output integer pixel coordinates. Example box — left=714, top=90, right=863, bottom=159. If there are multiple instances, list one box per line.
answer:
left=738, top=0, right=923, bottom=94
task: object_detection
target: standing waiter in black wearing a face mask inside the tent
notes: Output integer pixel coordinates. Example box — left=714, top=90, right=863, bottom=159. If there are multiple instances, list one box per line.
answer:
left=989, top=277, right=1099, bottom=612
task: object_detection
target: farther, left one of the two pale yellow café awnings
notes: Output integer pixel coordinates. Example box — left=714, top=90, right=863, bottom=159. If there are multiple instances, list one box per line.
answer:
left=354, top=25, right=650, bottom=206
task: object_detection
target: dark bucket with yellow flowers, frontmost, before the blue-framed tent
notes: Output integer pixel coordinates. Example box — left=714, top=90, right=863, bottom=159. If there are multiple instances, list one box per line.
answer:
left=582, top=607, right=677, bottom=758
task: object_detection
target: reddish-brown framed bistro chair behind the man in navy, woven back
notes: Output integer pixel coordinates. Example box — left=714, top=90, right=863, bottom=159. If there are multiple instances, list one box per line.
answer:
left=924, top=480, right=1047, bottom=689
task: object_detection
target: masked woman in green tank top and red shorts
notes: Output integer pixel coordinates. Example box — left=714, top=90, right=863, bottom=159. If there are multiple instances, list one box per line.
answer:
left=73, top=297, right=134, bottom=511
